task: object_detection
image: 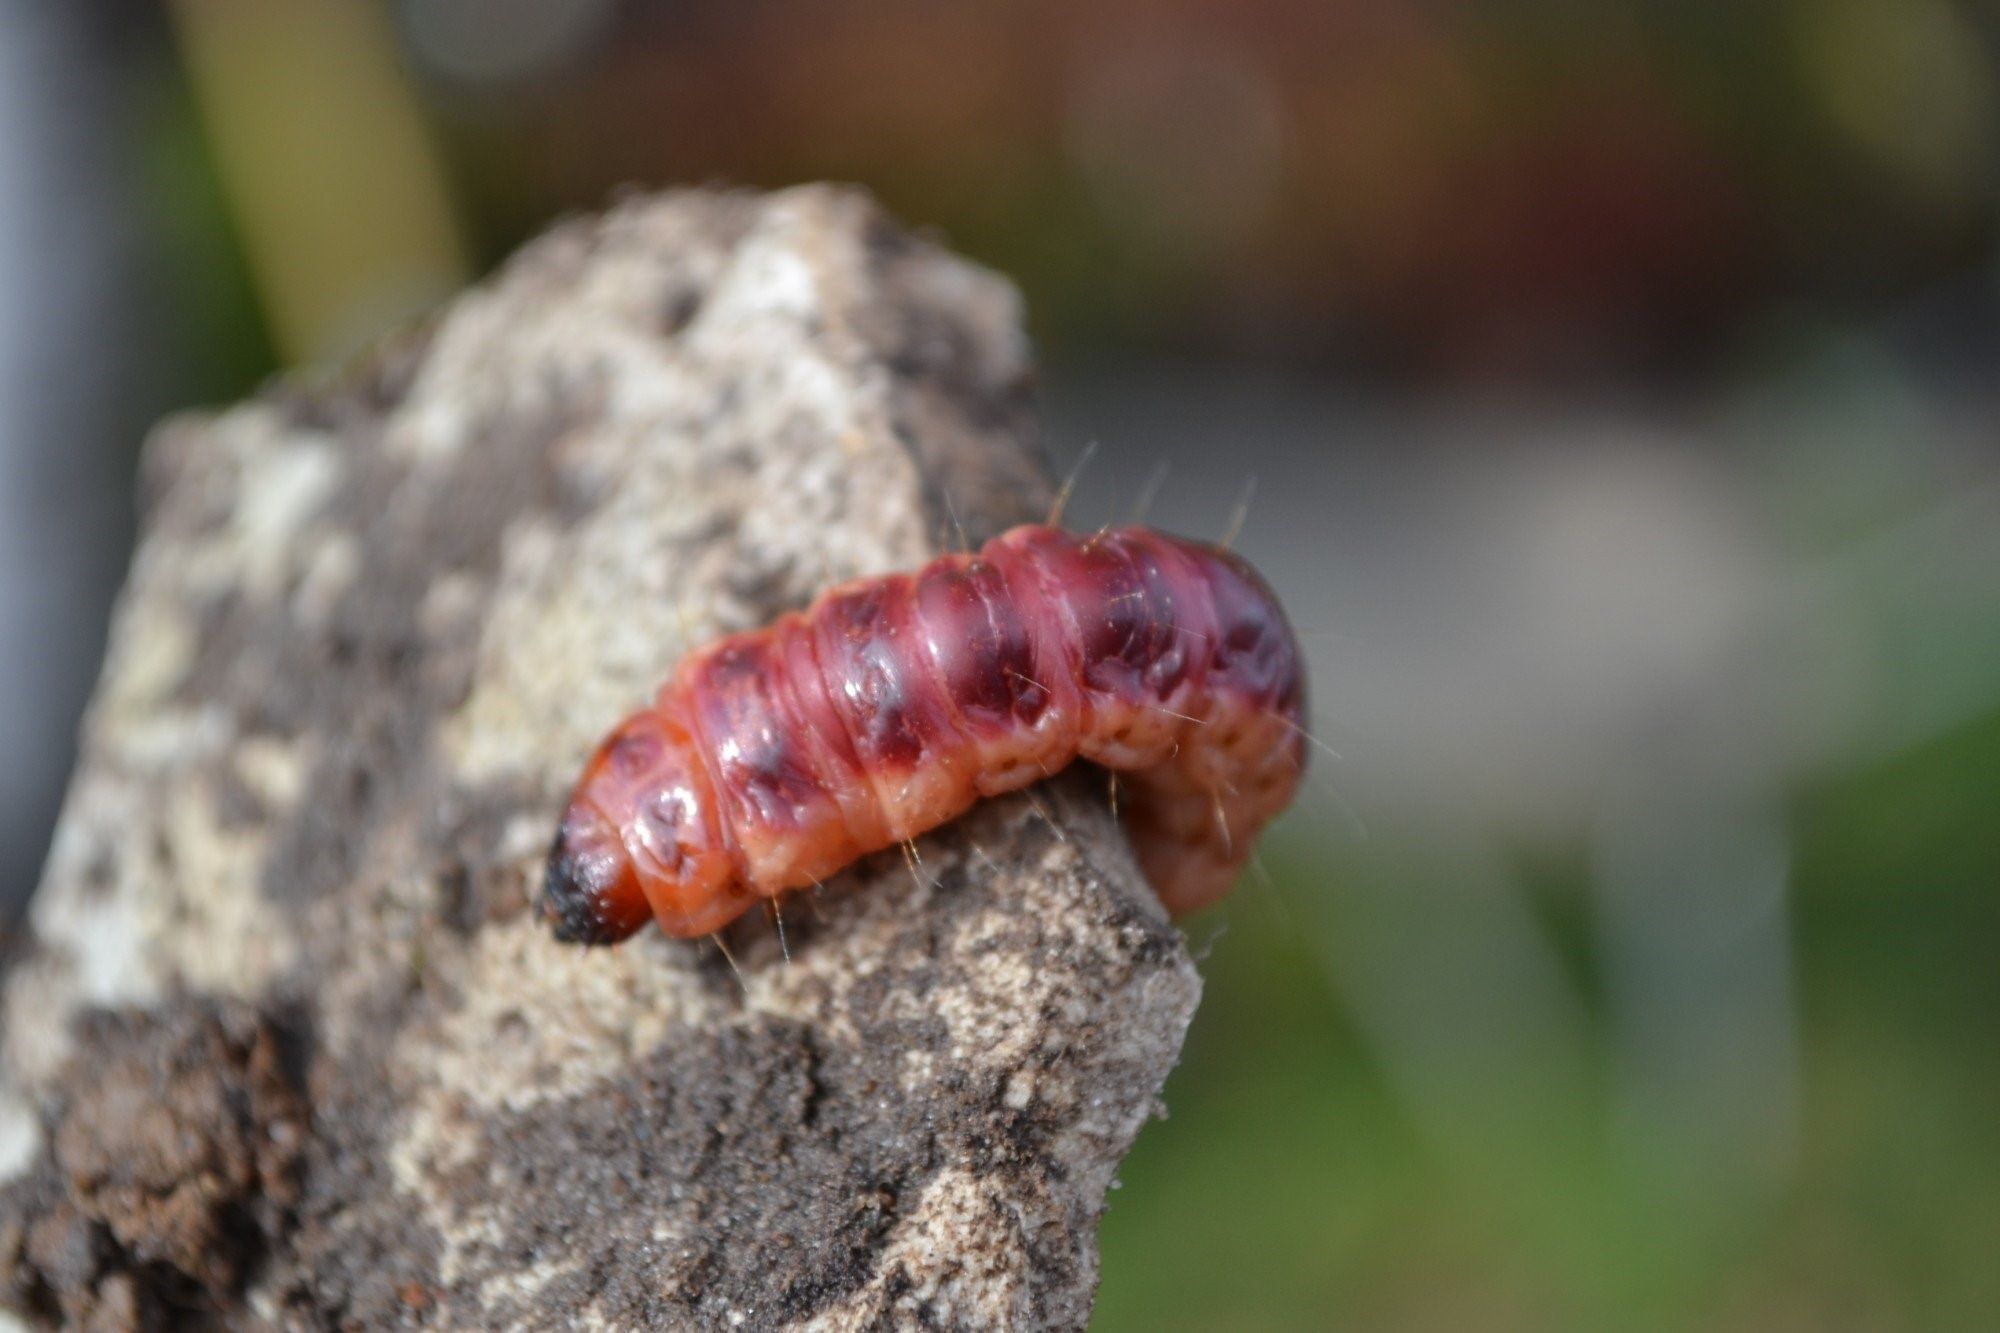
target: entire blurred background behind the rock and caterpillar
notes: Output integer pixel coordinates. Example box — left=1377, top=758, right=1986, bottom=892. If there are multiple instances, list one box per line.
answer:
left=0, top=0, right=2000, bottom=1329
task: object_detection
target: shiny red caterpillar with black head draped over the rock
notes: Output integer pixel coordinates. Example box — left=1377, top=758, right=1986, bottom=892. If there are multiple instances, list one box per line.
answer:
left=542, top=526, right=1306, bottom=943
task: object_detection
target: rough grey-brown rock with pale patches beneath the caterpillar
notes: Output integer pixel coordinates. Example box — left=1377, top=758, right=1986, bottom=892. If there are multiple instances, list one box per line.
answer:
left=0, top=188, right=1198, bottom=1329
